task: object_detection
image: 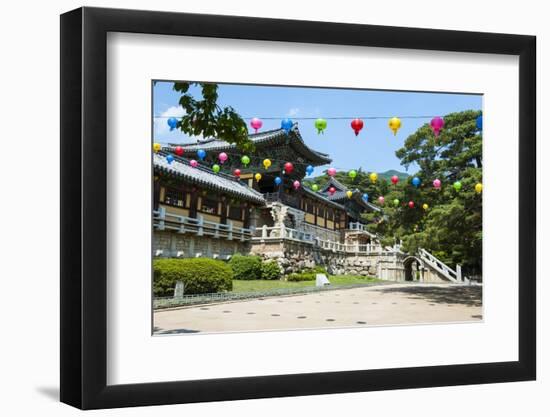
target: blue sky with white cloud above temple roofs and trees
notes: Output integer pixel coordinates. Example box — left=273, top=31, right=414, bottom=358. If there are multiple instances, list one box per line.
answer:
left=153, top=82, right=482, bottom=175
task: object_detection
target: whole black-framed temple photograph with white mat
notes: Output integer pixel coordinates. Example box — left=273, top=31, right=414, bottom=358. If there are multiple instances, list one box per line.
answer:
left=60, top=8, right=536, bottom=409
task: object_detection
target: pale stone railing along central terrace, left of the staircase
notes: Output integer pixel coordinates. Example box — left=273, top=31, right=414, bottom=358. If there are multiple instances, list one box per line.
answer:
left=252, top=225, right=399, bottom=254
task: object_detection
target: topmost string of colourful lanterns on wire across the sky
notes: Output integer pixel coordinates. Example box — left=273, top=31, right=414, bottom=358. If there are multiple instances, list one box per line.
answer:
left=162, top=116, right=483, bottom=138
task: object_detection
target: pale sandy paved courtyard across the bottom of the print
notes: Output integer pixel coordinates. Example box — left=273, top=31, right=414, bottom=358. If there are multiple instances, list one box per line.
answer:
left=154, top=284, right=482, bottom=335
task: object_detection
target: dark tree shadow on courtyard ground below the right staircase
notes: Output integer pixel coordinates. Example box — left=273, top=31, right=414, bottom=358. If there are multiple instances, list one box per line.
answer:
left=378, top=286, right=482, bottom=307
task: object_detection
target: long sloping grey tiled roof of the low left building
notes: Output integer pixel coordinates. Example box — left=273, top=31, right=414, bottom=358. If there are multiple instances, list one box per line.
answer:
left=153, top=152, right=265, bottom=205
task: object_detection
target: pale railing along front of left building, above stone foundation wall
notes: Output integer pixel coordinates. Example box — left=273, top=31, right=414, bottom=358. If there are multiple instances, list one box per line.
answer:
left=153, top=207, right=252, bottom=241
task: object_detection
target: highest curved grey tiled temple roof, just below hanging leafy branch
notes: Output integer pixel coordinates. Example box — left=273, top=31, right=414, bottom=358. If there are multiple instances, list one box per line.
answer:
left=167, top=123, right=332, bottom=166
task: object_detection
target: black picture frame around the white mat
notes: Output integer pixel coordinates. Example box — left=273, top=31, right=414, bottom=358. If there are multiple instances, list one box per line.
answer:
left=60, top=7, right=536, bottom=409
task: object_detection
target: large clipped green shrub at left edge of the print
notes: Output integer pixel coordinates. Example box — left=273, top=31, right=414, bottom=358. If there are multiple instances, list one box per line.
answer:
left=153, top=258, right=233, bottom=297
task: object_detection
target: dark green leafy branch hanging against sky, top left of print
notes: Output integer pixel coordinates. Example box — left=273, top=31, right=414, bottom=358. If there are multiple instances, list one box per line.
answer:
left=174, top=82, right=254, bottom=151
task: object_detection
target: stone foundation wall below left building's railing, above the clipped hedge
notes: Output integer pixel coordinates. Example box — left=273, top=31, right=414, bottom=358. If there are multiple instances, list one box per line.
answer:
left=153, top=231, right=250, bottom=258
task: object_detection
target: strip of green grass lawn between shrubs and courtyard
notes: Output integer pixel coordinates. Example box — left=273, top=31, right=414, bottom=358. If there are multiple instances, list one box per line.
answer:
left=233, top=275, right=381, bottom=292
